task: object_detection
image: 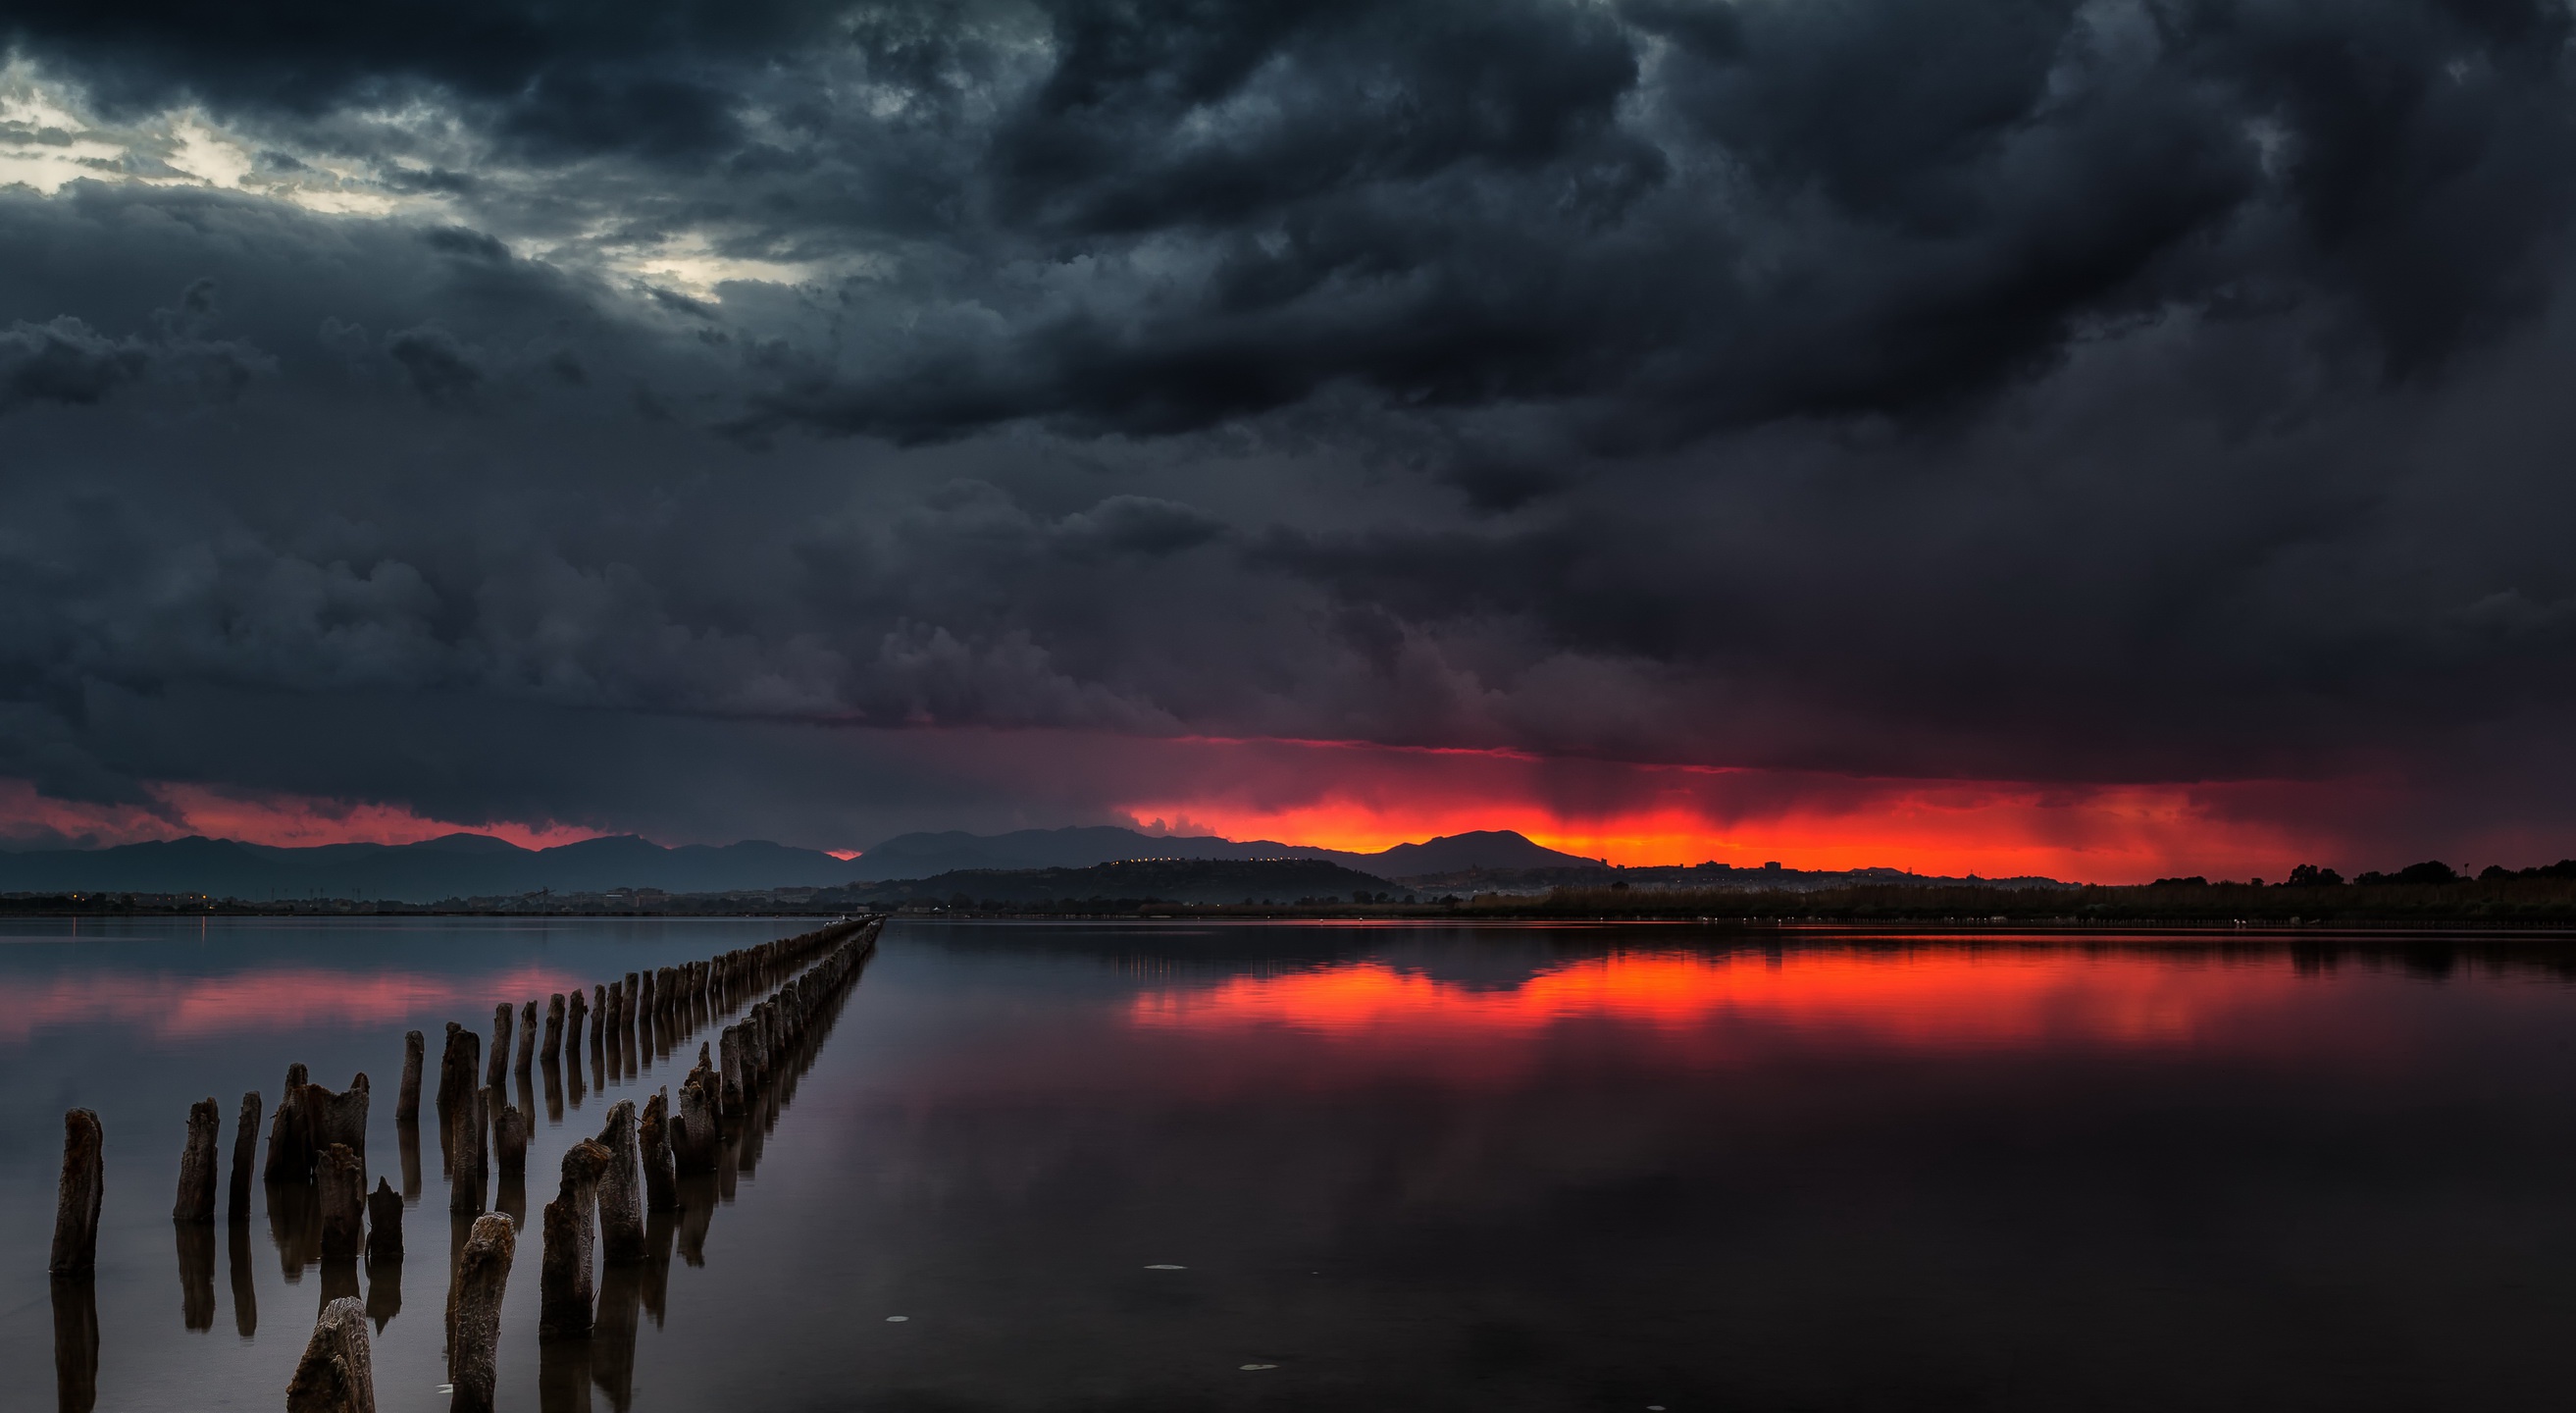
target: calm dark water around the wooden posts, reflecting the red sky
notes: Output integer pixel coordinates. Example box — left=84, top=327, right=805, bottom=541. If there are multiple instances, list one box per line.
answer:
left=0, top=920, right=2576, bottom=1413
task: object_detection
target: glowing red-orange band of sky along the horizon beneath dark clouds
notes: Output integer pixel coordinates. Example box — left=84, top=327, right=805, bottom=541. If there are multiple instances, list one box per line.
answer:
left=0, top=732, right=2558, bottom=882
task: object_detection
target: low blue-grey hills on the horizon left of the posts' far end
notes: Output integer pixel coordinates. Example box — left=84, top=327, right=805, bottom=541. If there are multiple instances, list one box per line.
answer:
left=0, top=833, right=857, bottom=903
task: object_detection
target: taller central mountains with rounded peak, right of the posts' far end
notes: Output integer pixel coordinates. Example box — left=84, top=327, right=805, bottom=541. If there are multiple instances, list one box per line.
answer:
left=857, top=825, right=1597, bottom=879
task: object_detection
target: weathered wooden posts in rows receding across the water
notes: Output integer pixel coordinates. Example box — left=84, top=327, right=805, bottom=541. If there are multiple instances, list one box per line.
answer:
left=49, top=917, right=884, bottom=1413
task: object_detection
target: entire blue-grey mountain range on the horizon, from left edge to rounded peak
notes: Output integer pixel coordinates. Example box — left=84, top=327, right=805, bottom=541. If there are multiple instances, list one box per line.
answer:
left=0, top=825, right=1594, bottom=903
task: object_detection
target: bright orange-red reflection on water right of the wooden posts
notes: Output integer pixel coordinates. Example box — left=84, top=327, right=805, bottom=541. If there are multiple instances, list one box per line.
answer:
left=1131, top=949, right=2300, bottom=1049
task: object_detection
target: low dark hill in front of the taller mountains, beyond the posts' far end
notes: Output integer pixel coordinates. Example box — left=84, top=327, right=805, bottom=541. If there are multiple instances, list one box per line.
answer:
left=860, top=859, right=1404, bottom=905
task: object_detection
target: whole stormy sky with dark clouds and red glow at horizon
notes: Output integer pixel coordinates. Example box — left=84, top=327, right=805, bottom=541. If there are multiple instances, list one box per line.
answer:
left=0, top=0, right=2576, bottom=882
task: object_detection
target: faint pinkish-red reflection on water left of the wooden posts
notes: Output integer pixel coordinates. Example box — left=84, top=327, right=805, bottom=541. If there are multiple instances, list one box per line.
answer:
left=0, top=967, right=580, bottom=1044
